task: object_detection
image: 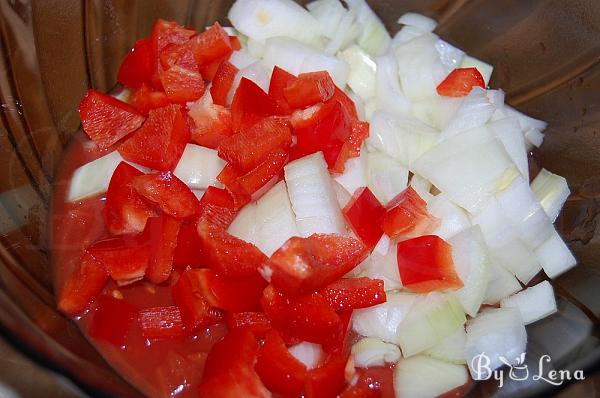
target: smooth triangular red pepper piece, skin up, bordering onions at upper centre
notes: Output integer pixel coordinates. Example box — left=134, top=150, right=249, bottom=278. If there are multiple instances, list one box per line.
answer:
left=231, top=77, right=281, bottom=132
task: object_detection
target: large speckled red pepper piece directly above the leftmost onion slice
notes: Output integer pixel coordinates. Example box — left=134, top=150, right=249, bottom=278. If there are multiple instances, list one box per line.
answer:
left=119, top=105, right=190, bottom=170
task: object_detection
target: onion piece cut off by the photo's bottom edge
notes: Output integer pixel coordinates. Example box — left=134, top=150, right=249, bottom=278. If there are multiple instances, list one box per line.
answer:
left=394, top=355, right=469, bottom=398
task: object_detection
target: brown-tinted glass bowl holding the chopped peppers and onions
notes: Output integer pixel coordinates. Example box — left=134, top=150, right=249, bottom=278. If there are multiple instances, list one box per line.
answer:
left=0, top=0, right=600, bottom=397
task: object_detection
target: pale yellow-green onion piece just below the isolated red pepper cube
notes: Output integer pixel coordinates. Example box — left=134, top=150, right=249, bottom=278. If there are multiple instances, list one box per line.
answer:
left=396, top=292, right=466, bottom=357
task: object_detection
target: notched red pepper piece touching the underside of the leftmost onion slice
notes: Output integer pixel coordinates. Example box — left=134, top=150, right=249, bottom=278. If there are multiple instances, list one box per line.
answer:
left=102, top=162, right=157, bottom=235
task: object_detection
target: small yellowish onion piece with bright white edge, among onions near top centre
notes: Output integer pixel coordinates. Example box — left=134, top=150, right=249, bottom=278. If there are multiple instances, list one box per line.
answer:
left=338, top=45, right=377, bottom=100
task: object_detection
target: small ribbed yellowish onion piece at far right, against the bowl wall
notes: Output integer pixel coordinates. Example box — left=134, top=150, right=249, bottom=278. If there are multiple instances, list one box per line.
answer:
left=531, top=169, right=571, bottom=222
